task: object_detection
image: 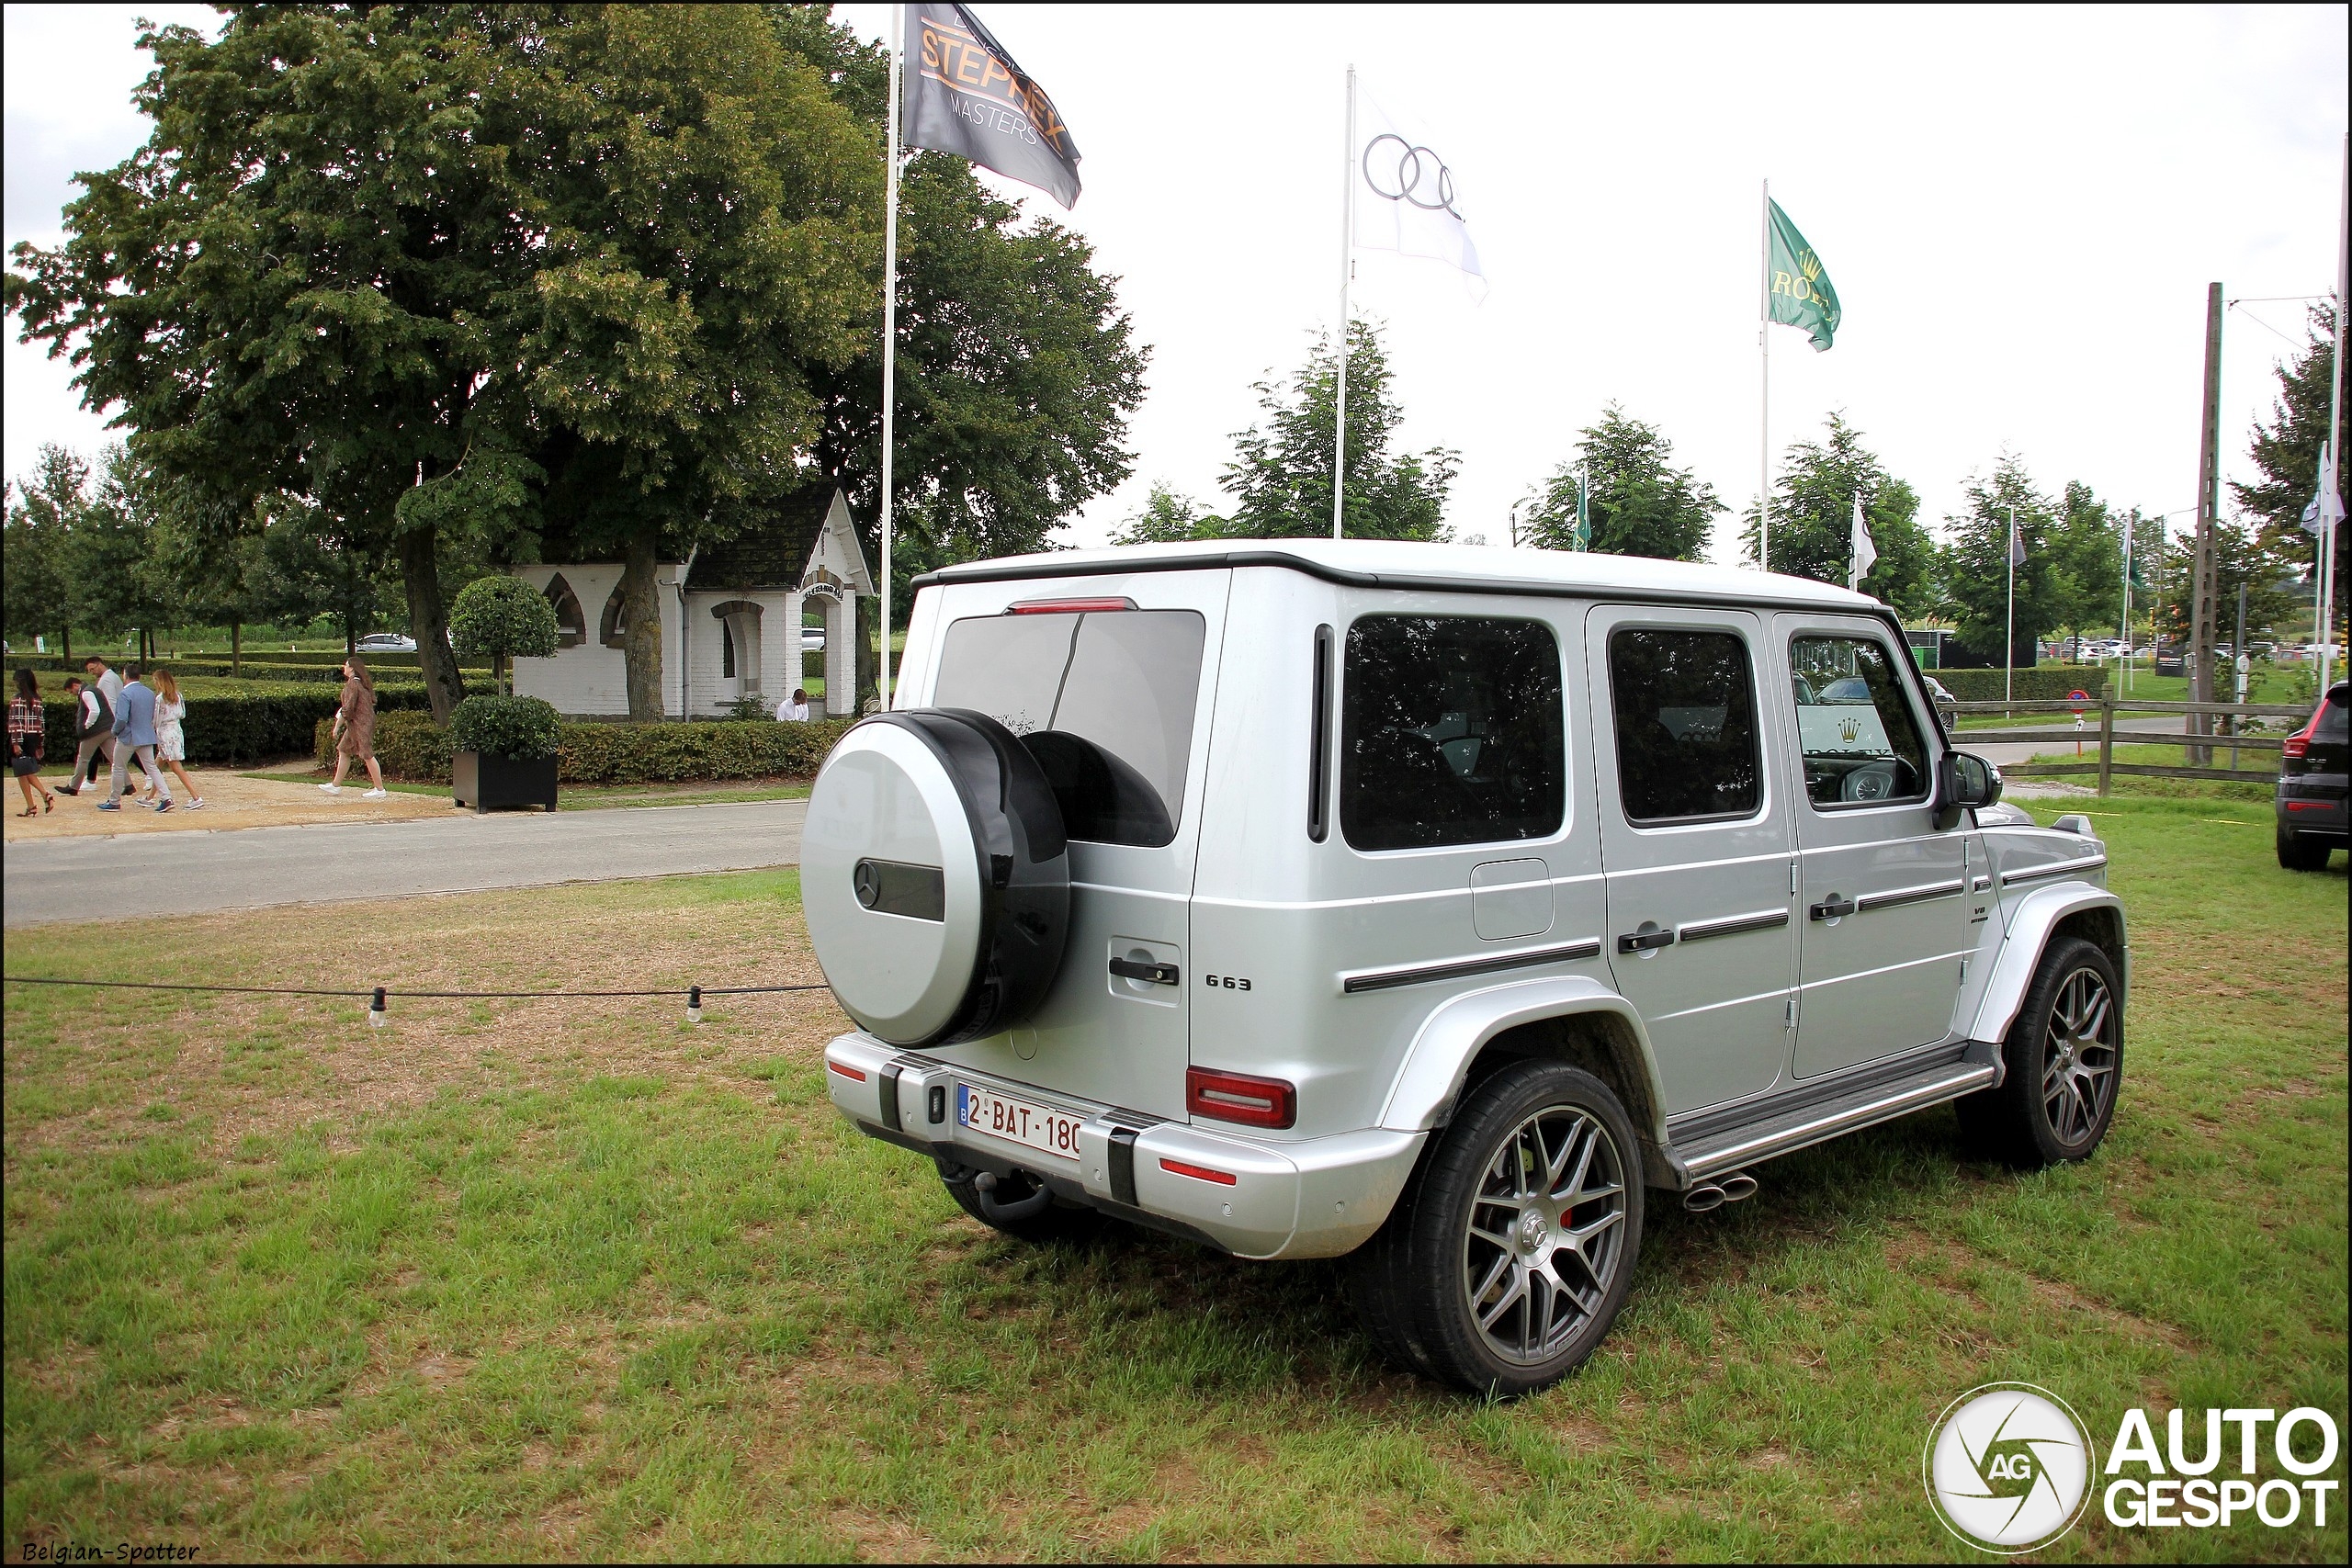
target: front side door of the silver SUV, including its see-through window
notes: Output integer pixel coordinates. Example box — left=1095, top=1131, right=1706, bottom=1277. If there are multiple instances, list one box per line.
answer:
left=1773, top=616, right=1969, bottom=1079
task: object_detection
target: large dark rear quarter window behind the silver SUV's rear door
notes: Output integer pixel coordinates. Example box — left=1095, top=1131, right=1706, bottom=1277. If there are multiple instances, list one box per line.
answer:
left=1339, top=616, right=1566, bottom=849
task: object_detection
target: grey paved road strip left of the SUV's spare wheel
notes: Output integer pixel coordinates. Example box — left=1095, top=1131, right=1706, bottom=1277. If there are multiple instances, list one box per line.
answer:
left=5, top=799, right=809, bottom=926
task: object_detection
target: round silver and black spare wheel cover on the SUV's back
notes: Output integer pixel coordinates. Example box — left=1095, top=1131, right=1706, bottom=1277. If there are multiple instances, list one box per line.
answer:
left=799, top=707, right=1070, bottom=1046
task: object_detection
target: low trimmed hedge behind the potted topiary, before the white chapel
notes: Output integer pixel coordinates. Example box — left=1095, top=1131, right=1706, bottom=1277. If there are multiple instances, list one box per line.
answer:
left=312, top=712, right=852, bottom=785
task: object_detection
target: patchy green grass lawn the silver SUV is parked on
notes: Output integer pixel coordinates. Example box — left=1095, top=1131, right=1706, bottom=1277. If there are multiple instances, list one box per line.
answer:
left=5, top=799, right=2347, bottom=1561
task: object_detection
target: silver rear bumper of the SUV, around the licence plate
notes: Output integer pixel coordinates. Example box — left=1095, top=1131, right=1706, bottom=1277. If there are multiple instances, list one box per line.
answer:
left=826, top=1034, right=1428, bottom=1258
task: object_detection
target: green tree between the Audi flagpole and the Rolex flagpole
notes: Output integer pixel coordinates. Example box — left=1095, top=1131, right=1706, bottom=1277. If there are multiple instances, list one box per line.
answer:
left=1520, top=402, right=1724, bottom=562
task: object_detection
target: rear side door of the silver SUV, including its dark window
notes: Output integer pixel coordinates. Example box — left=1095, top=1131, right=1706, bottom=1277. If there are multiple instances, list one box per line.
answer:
left=1585, top=604, right=1797, bottom=1114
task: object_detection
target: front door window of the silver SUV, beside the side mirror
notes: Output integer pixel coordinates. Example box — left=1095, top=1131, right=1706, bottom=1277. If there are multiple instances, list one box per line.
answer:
left=1788, top=637, right=1927, bottom=807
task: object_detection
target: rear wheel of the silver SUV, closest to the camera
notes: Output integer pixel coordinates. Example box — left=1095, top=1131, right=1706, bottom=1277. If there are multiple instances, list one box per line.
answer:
left=1355, top=1060, right=1642, bottom=1396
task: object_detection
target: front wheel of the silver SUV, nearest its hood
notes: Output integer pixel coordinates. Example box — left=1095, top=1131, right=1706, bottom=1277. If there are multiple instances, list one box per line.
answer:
left=1952, top=936, right=2124, bottom=1170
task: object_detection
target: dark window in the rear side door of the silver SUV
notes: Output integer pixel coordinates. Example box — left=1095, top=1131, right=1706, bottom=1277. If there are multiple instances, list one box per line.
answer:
left=1609, top=627, right=1764, bottom=823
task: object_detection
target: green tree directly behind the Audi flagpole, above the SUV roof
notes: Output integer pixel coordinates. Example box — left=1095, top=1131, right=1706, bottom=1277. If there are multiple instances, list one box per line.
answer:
left=1223, top=320, right=1461, bottom=541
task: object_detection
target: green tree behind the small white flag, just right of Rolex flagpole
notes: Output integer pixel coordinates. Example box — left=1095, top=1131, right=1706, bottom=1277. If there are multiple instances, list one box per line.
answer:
left=1740, top=412, right=1943, bottom=618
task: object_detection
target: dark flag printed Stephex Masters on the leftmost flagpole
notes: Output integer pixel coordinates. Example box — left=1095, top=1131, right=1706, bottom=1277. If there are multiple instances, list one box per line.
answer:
left=899, top=5, right=1077, bottom=207
